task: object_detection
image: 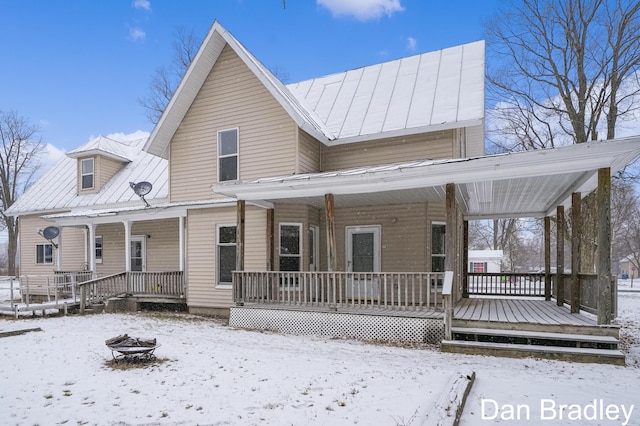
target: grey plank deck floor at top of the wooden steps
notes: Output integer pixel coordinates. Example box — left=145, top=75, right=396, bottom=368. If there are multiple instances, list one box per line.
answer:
left=453, top=298, right=597, bottom=326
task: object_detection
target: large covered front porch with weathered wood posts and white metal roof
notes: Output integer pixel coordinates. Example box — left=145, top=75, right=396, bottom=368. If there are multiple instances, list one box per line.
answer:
left=213, top=138, right=640, bottom=362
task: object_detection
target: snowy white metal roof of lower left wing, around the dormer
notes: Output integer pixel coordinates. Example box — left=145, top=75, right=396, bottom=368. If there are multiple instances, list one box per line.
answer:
left=6, top=137, right=169, bottom=216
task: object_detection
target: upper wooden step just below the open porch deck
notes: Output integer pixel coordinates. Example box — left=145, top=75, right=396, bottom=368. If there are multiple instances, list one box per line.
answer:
left=451, top=327, right=619, bottom=349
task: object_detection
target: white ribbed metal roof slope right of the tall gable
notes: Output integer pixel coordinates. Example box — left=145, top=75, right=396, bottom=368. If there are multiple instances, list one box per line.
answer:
left=287, top=41, right=484, bottom=144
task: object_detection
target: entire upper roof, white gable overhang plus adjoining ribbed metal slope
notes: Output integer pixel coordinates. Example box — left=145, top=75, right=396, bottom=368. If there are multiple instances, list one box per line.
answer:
left=144, top=21, right=484, bottom=158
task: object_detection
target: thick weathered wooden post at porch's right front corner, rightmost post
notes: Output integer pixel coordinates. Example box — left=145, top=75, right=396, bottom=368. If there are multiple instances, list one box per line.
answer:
left=596, top=167, right=612, bottom=324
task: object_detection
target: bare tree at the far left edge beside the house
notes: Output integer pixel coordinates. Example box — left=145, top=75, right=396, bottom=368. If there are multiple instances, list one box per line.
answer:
left=0, top=110, right=42, bottom=275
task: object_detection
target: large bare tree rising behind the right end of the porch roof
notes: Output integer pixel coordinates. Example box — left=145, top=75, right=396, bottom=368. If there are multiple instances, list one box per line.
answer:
left=486, top=0, right=640, bottom=269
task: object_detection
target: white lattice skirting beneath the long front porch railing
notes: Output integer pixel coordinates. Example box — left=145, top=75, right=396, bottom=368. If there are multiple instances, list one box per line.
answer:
left=229, top=307, right=444, bottom=343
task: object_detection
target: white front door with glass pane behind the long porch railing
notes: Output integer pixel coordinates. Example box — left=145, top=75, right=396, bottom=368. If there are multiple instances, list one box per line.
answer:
left=346, top=225, right=380, bottom=299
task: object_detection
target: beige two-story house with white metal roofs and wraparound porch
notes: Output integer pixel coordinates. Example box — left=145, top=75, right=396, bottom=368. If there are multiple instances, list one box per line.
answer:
left=9, top=22, right=640, bottom=364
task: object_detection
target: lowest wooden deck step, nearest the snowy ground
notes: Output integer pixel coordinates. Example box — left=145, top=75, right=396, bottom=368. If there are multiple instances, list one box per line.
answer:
left=441, top=340, right=625, bottom=365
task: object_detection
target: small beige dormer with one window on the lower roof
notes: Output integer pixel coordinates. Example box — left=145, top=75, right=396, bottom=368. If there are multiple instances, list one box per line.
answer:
left=67, top=136, right=131, bottom=195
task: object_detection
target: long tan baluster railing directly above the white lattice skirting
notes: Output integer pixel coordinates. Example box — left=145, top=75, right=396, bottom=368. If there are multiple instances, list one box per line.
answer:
left=233, top=271, right=444, bottom=310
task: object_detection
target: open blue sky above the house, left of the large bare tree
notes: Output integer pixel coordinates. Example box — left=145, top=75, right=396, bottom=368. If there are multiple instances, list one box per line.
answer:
left=0, top=0, right=500, bottom=151
